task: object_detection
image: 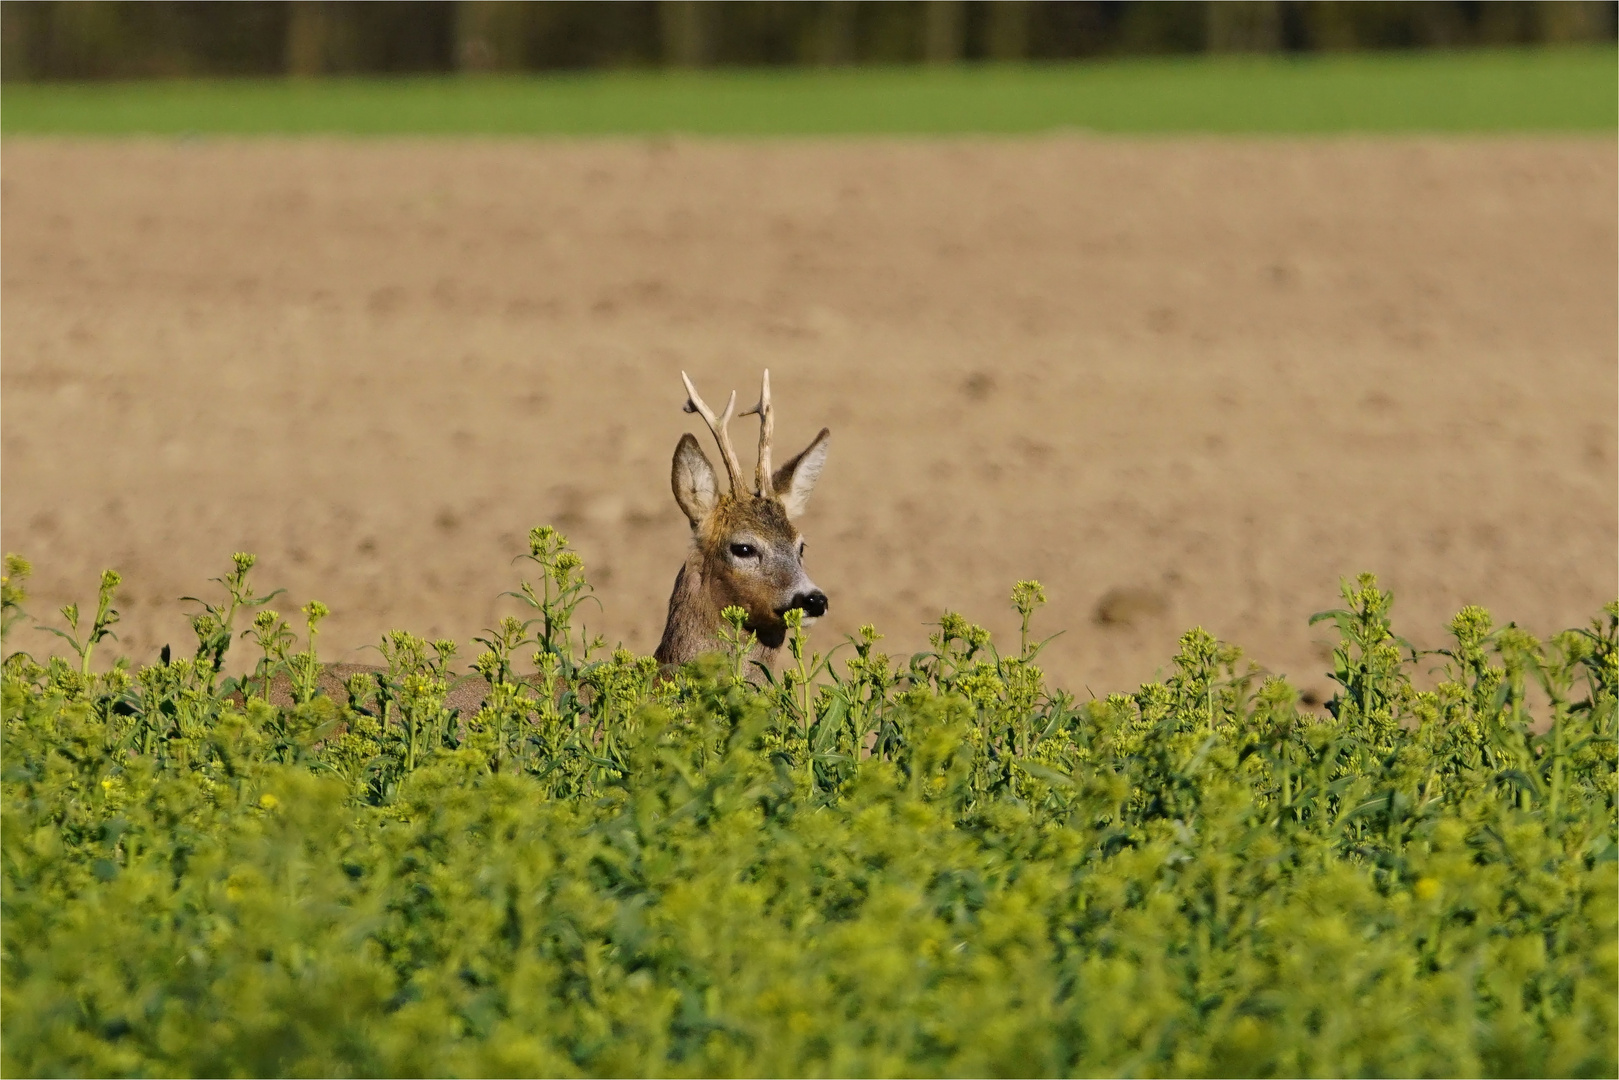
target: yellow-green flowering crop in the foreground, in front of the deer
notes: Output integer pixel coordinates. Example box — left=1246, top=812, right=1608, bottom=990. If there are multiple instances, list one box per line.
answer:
left=0, top=529, right=1619, bottom=1077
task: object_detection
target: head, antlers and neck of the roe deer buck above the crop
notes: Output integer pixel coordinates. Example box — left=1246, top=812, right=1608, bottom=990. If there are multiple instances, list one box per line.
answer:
left=656, top=371, right=831, bottom=665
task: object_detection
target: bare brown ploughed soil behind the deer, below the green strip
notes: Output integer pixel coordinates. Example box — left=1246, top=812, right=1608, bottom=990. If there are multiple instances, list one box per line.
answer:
left=0, top=136, right=1619, bottom=693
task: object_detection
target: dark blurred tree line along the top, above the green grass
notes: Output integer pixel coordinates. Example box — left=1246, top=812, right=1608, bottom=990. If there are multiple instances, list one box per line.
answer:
left=0, top=0, right=1619, bottom=79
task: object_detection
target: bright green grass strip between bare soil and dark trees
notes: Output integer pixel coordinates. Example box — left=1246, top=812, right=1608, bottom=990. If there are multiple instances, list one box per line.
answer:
left=0, top=47, right=1619, bottom=136
